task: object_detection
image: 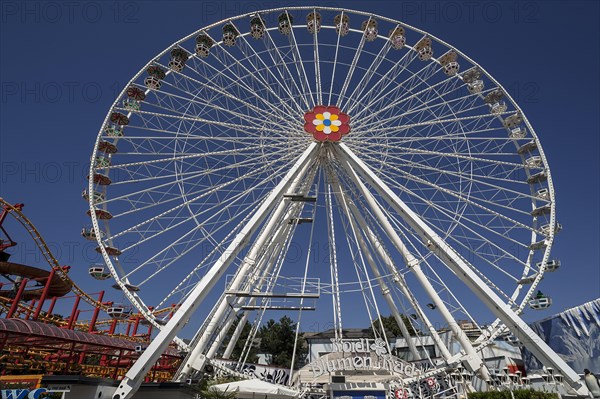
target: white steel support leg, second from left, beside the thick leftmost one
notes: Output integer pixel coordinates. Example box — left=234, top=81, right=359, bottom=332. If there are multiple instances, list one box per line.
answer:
left=175, top=152, right=316, bottom=382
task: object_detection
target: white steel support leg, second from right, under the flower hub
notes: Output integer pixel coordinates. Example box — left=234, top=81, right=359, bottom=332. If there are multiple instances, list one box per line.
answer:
left=337, top=148, right=490, bottom=381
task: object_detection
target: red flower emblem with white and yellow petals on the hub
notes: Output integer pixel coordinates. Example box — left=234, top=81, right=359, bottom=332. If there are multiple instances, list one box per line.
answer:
left=304, top=105, right=350, bottom=141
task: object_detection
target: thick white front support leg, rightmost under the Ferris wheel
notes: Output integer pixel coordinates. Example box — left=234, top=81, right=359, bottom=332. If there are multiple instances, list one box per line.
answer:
left=338, top=144, right=588, bottom=396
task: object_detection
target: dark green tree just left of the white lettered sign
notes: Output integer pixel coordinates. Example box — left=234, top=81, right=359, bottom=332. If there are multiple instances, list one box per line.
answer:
left=258, top=316, right=308, bottom=368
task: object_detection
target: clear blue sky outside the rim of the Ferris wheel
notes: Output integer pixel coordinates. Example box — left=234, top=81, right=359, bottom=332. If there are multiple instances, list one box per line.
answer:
left=0, top=1, right=600, bottom=338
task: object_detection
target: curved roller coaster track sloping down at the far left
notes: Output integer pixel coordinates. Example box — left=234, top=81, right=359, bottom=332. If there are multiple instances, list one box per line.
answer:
left=0, top=198, right=108, bottom=312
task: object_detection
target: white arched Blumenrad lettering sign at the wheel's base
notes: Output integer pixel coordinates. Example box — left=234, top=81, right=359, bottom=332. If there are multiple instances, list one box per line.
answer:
left=308, top=338, right=420, bottom=378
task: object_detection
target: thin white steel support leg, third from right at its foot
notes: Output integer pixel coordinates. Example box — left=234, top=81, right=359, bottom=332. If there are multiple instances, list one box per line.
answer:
left=332, top=172, right=452, bottom=362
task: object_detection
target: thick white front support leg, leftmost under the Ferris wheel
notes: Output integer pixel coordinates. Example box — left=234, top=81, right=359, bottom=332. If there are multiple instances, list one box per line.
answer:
left=113, top=143, right=317, bottom=399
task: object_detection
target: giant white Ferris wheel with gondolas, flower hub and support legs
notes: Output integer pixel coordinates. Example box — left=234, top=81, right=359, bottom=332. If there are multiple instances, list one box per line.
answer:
left=84, top=7, right=578, bottom=398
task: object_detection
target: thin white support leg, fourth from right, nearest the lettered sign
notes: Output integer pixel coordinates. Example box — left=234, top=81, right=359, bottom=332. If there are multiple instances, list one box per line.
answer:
left=332, top=180, right=419, bottom=360
